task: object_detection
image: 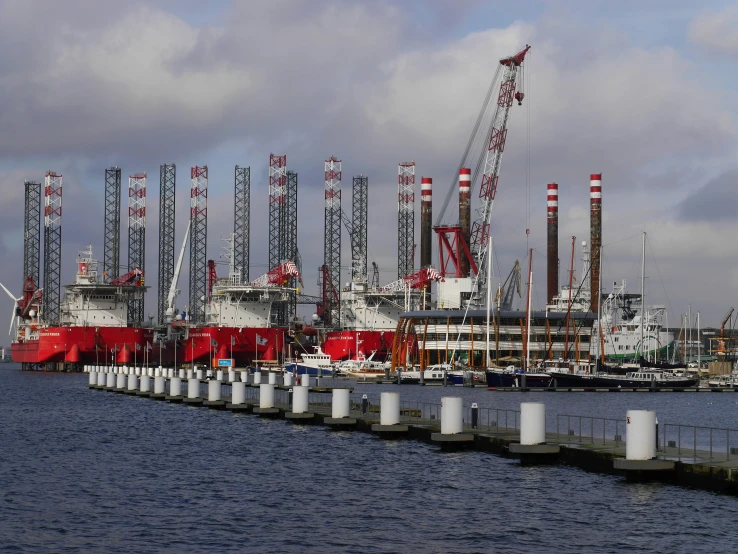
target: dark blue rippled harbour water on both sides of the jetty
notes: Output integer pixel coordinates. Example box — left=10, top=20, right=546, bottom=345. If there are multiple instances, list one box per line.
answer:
left=0, top=369, right=738, bottom=553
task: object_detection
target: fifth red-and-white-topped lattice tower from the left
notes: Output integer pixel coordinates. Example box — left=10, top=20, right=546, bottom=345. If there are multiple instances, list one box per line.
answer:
left=323, top=156, right=341, bottom=328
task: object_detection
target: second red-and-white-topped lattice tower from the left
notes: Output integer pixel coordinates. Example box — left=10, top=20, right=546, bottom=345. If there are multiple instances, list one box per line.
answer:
left=128, top=173, right=146, bottom=325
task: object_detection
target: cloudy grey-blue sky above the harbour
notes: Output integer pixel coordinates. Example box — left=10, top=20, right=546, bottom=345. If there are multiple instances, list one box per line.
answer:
left=0, top=0, right=738, bottom=328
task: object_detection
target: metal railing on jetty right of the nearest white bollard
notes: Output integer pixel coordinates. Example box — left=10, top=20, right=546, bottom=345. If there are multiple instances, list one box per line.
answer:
left=656, top=423, right=738, bottom=462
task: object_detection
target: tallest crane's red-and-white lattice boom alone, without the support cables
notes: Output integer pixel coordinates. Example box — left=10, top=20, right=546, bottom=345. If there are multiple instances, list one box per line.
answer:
left=470, top=45, right=530, bottom=290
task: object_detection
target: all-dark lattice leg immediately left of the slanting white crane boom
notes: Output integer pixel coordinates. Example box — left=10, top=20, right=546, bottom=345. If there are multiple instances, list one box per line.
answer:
left=157, top=164, right=177, bottom=325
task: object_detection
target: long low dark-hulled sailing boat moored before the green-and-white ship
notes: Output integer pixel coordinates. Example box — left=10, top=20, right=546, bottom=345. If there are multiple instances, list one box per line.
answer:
left=552, top=369, right=699, bottom=389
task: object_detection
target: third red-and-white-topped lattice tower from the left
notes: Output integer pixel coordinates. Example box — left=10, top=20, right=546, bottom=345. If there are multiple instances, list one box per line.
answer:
left=189, top=166, right=208, bottom=323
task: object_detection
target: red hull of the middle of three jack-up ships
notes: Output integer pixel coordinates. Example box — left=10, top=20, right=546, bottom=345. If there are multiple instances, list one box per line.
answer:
left=177, top=326, right=286, bottom=366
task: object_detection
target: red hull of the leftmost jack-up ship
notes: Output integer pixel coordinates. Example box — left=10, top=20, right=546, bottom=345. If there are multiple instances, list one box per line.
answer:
left=11, top=327, right=154, bottom=365
